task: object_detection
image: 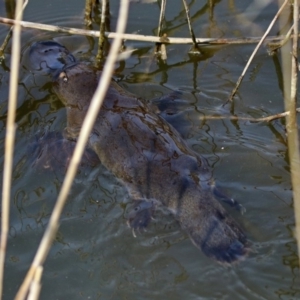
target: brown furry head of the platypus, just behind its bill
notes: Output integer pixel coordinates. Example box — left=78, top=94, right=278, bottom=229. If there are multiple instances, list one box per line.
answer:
left=54, top=63, right=99, bottom=110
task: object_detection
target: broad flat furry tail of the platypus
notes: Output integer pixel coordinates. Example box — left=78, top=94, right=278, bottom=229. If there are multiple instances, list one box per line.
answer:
left=179, top=195, right=250, bottom=263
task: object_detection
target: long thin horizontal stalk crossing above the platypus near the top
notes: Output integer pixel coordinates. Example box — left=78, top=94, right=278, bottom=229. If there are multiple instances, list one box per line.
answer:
left=0, top=17, right=300, bottom=45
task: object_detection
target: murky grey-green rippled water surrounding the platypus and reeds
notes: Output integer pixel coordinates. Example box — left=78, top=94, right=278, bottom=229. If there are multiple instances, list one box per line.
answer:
left=0, top=0, right=300, bottom=300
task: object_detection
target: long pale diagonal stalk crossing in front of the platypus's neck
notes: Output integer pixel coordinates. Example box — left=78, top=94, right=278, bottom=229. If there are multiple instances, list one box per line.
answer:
left=15, top=0, right=129, bottom=300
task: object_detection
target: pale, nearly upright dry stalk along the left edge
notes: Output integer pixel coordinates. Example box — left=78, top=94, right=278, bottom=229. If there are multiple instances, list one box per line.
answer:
left=0, top=0, right=23, bottom=298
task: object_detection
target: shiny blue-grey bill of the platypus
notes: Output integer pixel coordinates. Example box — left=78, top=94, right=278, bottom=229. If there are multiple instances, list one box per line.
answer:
left=29, top=41, right=76, bottom=76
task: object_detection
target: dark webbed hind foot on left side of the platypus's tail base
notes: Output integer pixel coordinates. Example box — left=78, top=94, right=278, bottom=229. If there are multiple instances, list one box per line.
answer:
left=127, top=200, right=154, bottom=231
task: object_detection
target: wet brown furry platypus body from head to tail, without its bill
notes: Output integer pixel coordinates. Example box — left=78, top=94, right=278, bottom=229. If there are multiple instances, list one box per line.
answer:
left=28, top=40, right=249, bottom=263
